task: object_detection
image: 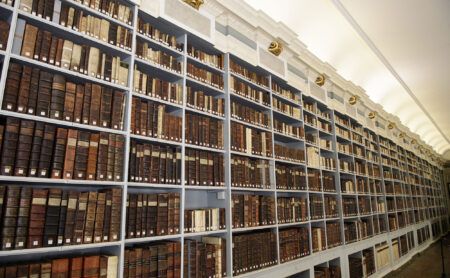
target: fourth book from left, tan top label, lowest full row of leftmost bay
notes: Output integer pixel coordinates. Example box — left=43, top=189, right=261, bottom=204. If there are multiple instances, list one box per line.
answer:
left=43, top=188, right=62, bottom=247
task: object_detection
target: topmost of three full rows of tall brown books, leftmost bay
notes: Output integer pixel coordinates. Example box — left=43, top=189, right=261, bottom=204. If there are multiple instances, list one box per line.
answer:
left=3, top=63, right=125, bottom=130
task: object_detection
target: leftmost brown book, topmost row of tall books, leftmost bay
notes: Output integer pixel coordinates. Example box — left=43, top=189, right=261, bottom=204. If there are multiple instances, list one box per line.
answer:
left=2, top=63, right=23, bottom=111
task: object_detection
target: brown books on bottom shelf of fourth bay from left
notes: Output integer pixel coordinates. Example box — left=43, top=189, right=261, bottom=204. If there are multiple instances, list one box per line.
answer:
left=233, top=231, right=277, bottom=275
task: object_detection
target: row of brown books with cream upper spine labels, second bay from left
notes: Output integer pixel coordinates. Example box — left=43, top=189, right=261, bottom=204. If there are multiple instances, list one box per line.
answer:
left=128, top=143, right=181, bottom=184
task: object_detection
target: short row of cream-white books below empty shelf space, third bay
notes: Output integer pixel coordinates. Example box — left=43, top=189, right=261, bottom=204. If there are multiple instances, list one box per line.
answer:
left=184, top=208, right=226, bottom=233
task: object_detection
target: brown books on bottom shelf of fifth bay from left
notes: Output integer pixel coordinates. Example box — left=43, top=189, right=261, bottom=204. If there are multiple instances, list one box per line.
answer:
left=279, top=227, right=310, bottom=263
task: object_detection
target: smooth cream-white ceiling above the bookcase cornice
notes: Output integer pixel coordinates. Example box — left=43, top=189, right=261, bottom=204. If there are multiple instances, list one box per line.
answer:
left=245, top=0, right=450, bottom=156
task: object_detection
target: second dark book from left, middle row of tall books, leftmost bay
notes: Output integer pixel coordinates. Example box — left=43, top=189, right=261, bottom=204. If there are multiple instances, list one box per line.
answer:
left=14, top=120, right=35, bottom=176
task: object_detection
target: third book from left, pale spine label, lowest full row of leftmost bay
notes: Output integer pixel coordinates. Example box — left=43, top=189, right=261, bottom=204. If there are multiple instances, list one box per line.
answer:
left=27, top=188, right=48, bottom=248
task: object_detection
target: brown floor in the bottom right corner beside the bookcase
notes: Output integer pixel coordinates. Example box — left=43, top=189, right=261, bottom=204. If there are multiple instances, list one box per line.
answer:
left=385, top=233, right=450, bottom=278
